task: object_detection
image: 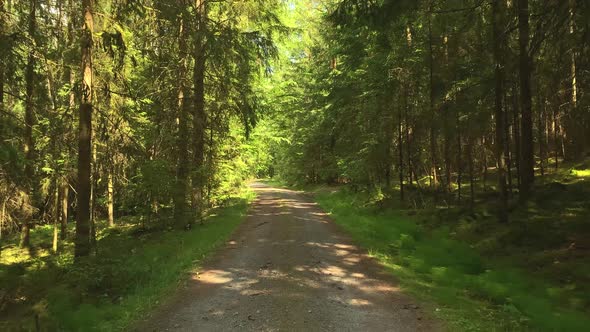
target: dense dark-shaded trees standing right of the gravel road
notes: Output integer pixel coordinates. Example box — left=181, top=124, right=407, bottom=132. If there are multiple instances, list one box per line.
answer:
left=270, top=1, right=590, bottom=205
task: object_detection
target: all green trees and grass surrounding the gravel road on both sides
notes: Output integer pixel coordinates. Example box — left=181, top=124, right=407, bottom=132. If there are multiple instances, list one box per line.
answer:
left=0, top=0, right=590, bottom=331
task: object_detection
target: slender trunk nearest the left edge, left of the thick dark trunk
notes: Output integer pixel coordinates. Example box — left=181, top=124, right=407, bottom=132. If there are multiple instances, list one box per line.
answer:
left=20, top=0, right=37, bottom=247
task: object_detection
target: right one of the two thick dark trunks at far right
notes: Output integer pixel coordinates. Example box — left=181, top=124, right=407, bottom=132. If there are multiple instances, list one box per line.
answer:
left=518, top=0, right=535, bottom=200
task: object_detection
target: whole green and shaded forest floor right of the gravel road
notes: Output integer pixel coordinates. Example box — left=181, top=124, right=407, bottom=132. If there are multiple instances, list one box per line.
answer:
left=274, top=164, right=590, bottom=331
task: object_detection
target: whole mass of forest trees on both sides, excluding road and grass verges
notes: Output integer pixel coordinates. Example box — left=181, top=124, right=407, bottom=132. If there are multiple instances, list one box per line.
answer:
left=0, top=0, right=590, bottom=329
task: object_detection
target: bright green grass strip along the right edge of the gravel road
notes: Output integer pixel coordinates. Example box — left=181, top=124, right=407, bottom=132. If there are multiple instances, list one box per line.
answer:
left=316, top=190, right=590, bottom=331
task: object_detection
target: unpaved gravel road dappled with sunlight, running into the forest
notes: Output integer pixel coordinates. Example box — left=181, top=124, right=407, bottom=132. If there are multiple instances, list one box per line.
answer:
left=136, top=183, right=442, bottom=332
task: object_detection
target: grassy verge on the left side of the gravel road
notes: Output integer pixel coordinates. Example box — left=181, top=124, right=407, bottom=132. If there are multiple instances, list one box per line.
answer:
left=0, top=188, right=254, bottom=331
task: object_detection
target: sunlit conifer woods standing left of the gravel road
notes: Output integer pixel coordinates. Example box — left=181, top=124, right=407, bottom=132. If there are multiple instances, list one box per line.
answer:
left=0, top=0, right=280, bottom=257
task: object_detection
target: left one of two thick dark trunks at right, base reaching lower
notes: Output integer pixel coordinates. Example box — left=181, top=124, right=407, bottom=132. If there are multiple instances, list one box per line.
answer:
left=492, top=0, right=508, bottom=222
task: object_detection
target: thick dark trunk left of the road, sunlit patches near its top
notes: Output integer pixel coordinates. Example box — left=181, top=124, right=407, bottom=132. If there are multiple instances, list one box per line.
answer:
left=74, top=0, right=94, bottom=257
